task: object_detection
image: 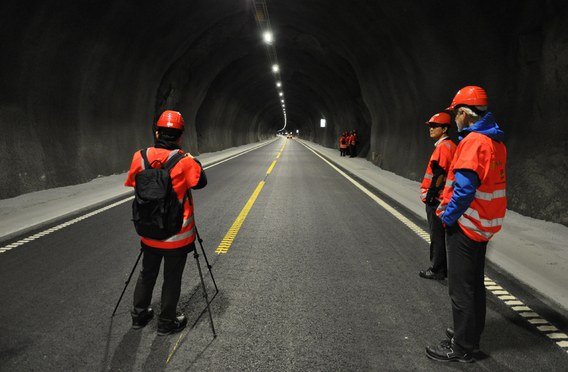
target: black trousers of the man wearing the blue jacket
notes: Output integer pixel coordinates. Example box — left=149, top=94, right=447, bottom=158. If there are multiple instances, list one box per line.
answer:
left=446, top=224, right=487, bottom=352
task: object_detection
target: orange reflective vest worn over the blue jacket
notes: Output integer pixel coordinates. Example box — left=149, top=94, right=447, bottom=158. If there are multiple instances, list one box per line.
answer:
left=437, top=132, right=507, bottom=242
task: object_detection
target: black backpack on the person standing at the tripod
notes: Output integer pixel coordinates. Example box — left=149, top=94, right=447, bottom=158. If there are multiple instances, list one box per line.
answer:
left=132, top=150, right=185, bottom=240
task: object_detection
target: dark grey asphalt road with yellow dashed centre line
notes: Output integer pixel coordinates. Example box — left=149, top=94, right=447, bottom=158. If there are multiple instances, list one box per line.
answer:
left=0, top=139, right=568, bottom=371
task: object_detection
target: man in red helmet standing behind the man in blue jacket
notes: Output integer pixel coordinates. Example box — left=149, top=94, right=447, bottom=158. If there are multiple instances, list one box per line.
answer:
left=418, top=112, right=456, bottom=280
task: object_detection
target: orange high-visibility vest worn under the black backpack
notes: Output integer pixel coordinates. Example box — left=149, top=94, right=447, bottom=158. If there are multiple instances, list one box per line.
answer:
left=124, top=147, right=201, bottom=249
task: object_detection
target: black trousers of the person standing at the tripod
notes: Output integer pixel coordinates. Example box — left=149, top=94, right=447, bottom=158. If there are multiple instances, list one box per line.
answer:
left=134, top=249, right=187, bottom=321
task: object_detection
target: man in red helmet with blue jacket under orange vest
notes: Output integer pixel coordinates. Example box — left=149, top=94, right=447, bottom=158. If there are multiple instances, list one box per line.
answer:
left=426, top=86, right=507, bottom=362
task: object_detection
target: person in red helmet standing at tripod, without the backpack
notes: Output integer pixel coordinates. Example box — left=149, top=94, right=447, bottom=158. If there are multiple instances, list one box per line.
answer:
left=124, top=110, right=207, bottom=335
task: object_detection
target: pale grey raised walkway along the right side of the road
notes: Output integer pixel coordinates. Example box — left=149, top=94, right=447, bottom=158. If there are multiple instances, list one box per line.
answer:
left=299, top=140, right=568, bottom=317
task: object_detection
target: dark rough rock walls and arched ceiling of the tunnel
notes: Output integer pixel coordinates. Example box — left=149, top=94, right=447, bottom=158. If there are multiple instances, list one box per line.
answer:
left=0, top=0, right=568, bottom=225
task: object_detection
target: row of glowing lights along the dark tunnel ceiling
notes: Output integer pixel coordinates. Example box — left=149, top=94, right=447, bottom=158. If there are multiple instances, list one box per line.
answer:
left=251, top=0, right=287, bottom=131
